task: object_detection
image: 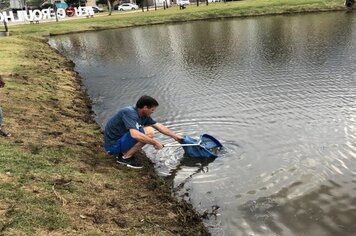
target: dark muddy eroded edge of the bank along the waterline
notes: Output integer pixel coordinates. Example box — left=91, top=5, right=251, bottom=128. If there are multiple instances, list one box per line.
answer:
left=52, top=43, right=210, bottom=235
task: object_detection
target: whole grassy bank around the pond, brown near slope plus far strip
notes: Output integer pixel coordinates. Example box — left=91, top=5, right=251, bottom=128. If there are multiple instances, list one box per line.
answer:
left=0, top=0, right=350, bottom=235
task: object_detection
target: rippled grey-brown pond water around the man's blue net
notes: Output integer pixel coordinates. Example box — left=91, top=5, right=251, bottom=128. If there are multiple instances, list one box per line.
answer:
left=50, top=12, right=356, bottom=235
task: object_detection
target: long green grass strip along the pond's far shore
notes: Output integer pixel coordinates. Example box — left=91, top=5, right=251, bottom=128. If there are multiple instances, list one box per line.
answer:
left=5, top=0, right=345, bottom=35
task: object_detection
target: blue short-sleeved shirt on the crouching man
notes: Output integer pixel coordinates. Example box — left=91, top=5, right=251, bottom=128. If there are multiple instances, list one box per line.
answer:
left=104, top=106, right=157, bottom=147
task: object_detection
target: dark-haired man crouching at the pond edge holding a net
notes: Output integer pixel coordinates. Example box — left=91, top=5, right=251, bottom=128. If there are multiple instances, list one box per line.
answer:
left=104, top=95, right=183, bottom=169
